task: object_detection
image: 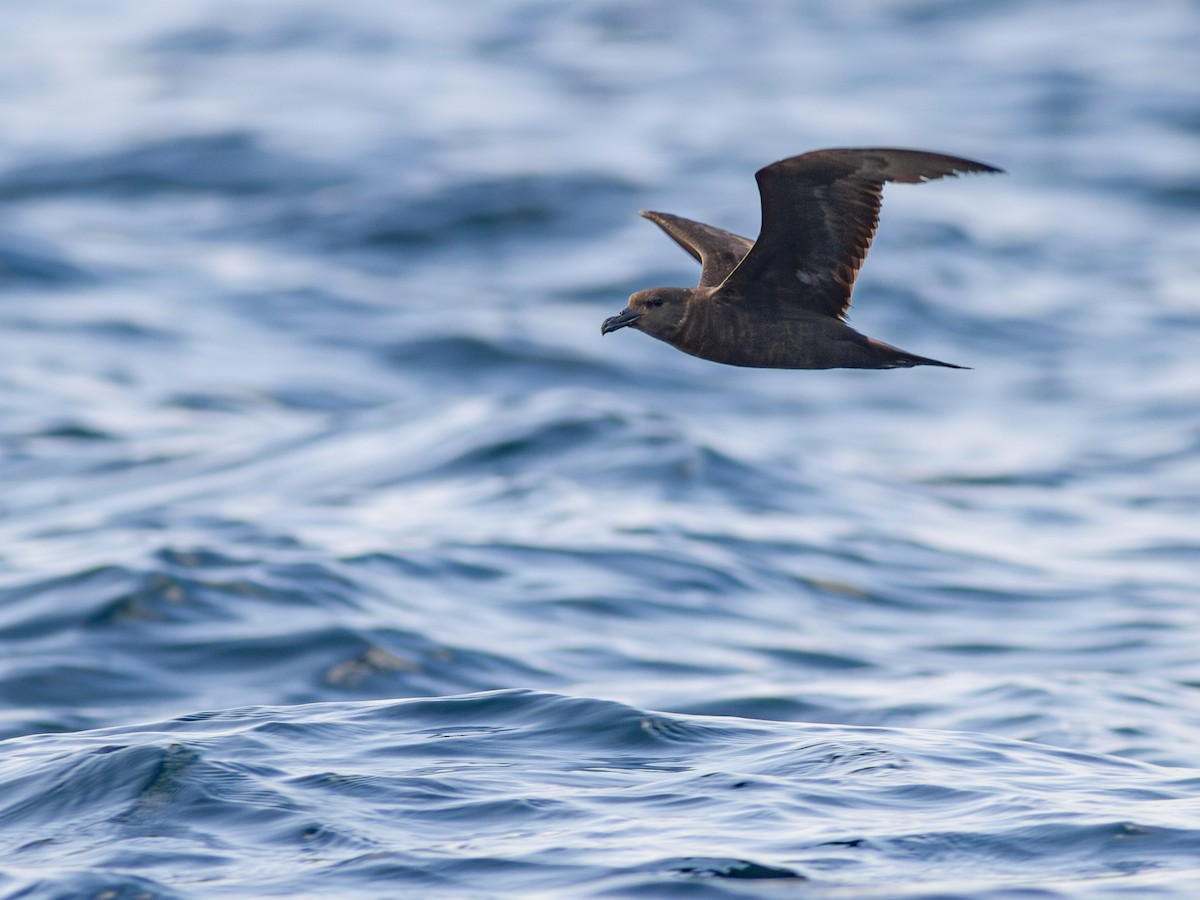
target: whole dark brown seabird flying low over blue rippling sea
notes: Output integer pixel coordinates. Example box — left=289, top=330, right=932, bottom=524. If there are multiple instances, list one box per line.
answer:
left=600, top=149, right=1002, bottom=368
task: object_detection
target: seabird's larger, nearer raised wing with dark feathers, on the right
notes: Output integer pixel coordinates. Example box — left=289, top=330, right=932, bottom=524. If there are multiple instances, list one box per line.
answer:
left=718, top=149, right=1000, bottom=318
